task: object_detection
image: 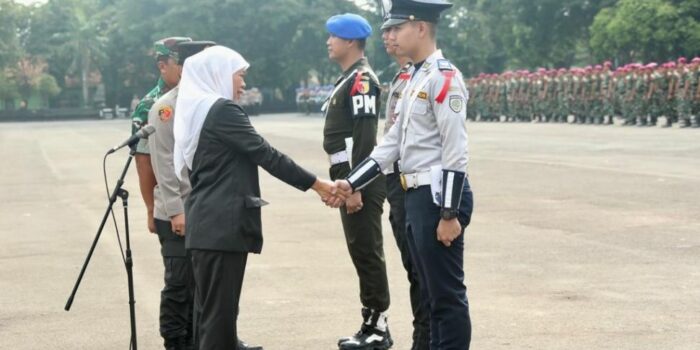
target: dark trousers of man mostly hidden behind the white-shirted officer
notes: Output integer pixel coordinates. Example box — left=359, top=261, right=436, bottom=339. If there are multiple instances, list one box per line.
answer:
left=386, top=172, right=430, bottom=340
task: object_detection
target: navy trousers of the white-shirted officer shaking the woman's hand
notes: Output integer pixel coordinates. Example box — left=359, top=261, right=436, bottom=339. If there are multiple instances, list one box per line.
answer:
left=406, top=183, right=473, bottom=350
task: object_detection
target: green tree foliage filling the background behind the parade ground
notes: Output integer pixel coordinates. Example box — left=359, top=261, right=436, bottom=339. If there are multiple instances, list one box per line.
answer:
left=0, top=0, right=700, bottom=105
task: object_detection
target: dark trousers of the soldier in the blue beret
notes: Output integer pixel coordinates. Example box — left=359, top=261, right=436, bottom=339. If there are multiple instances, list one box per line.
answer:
left=340, top=176, right=390, bottom=312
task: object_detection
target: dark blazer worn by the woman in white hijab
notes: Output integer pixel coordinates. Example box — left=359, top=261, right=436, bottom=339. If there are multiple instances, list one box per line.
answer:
left=185, top=98, right=316, bottom=253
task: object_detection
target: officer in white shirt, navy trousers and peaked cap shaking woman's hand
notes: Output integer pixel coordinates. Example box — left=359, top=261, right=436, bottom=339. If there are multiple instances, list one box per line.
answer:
left=338, top=0, right=473, bottom=350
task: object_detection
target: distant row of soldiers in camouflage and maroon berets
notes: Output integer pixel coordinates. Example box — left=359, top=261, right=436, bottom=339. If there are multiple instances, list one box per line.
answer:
left=467, top=57, right=700, bottom=127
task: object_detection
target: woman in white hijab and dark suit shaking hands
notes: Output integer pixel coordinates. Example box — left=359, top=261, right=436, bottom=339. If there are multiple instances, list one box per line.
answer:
left=174, top=46, right=341, bottom=350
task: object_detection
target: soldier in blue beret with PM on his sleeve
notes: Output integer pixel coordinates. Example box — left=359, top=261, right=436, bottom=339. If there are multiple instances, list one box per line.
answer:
left=322, top=13, right=393, bottom=350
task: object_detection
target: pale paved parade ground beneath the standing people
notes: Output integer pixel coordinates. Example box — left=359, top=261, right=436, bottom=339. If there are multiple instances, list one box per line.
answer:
left=0, top=114, right=700, bottom=350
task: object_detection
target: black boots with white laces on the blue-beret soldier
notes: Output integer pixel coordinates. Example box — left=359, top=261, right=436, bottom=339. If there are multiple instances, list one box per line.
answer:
left=338, top=308, right=394, bottom=350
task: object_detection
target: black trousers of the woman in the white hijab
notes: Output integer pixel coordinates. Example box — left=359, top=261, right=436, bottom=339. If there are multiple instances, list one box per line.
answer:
left=190, top=249, right=248, bottom=350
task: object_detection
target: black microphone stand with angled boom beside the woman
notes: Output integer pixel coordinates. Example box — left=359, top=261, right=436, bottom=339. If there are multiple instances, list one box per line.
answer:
left=64, top=147, right=138, bottom=350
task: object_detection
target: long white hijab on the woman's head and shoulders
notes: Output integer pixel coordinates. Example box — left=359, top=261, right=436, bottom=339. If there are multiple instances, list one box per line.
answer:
left=173, top=46, right=250, bottom=178
